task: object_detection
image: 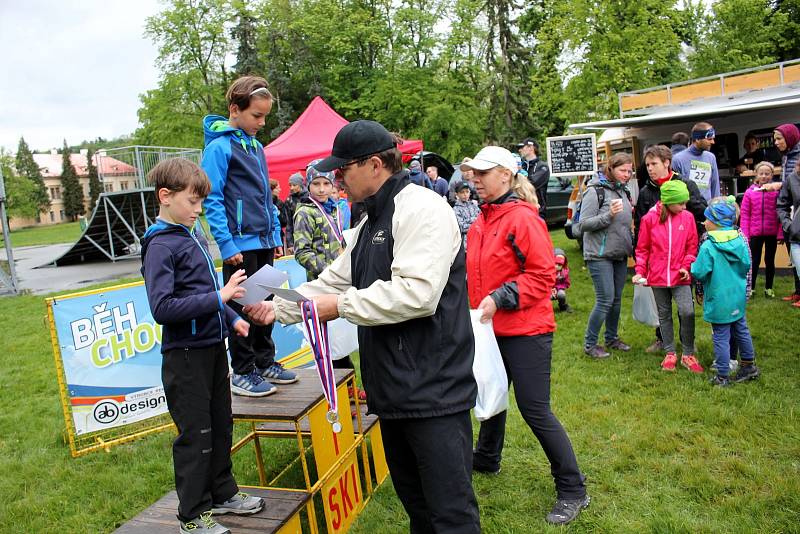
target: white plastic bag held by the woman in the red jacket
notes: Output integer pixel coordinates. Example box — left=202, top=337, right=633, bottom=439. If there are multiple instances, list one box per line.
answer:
left=469, top=310, right=508, bottom=421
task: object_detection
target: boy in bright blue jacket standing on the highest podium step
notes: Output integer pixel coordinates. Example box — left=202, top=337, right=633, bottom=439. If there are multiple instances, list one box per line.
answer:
left=202, top=76, right=297, bottom=397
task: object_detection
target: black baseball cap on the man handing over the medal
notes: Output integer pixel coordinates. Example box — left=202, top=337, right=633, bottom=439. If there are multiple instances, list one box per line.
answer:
left=314, top=120, right=397, bottom=172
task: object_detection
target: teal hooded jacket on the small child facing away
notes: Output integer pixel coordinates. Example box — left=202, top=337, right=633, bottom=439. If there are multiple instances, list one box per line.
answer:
left=692, top=229, right=751, bottom=324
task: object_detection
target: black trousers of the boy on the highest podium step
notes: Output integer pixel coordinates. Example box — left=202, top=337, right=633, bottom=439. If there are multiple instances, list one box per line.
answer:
left=222, top=248, right=275, bottom=375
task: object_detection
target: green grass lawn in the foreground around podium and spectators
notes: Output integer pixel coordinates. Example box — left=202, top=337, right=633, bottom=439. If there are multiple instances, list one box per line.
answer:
left=0, top=231, right=800, bottom=534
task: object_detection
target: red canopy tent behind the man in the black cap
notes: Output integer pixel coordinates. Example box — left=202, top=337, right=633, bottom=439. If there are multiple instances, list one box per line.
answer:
left=264, top=96, right=422, bottom=199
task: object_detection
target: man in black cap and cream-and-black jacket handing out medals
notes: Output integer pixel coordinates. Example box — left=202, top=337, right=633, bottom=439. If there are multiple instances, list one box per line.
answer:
left=245, top=120, right=480, bottom=534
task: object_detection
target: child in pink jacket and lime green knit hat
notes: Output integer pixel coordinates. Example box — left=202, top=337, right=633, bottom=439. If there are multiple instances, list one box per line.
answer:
left=633, top=180, right=703, bottom=373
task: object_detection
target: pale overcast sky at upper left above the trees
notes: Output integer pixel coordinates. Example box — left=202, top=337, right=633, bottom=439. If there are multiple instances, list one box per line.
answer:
left=0, top=0, right=161, bottom=151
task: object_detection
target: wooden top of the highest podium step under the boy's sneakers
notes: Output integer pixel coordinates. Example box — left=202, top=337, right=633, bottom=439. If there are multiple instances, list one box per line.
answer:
left=231, top=368, right=354, bottom=421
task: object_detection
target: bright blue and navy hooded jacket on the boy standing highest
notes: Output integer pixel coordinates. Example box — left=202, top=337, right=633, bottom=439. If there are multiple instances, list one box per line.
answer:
left=202, top=115, right=282, bottom=259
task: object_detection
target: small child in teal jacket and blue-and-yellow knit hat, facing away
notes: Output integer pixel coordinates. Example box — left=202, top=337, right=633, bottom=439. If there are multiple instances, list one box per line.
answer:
left=692, top=197, right=760, bottom=386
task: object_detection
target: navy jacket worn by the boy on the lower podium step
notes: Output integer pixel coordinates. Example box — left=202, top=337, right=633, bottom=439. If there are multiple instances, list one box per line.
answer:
left=142, top=219, right=241, bottom=353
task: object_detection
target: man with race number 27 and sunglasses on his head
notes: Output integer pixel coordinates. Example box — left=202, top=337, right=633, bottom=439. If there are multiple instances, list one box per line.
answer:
left=672, top=122, right=720, bottom=202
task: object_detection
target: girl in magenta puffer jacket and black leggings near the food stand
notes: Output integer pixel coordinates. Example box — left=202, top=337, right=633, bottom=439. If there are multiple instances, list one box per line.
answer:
left=739, top=161, right=783, bottom=298
